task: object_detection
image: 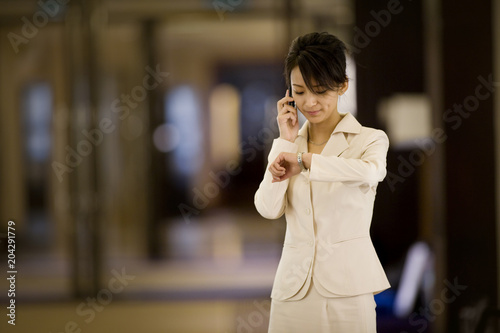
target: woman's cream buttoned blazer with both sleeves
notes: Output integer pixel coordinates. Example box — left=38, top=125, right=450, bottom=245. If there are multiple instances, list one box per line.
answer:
left=255, top=113, right=390, bottom=300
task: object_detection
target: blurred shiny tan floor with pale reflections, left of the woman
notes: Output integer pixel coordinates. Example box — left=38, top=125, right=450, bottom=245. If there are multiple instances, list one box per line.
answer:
left=2, top=253, right=277, bottom=333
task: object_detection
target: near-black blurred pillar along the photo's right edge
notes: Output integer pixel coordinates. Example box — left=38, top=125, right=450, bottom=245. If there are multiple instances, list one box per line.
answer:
left=437, top=0, right=499, bottom=332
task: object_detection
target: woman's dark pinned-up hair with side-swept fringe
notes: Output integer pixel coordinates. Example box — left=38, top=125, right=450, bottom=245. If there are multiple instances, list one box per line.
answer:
left=284, top=32, right=348, bottom=92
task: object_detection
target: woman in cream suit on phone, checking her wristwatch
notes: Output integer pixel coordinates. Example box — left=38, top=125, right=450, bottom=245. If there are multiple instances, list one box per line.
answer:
left=255, top=33, right=390, bottom=333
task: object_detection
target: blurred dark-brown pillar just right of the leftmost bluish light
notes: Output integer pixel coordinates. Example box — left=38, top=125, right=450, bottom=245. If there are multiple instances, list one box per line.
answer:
left=66, top=0, right=103, bottom=297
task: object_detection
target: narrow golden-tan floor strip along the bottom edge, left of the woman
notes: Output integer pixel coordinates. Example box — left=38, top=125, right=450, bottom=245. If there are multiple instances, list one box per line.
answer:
left=18, top=299, right=270, bottom=333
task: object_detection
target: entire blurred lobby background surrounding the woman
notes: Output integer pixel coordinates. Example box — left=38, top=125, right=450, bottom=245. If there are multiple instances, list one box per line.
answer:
left=0, top=0, right=500, bottom=333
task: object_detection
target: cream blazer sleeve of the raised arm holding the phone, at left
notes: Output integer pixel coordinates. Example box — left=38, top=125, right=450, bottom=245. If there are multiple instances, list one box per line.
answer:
left=254, top=138, right=298, bottom=219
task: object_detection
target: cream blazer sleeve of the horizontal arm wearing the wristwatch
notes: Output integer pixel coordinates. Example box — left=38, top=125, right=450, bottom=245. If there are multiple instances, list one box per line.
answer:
left=309, top=130, right=389, bottom=186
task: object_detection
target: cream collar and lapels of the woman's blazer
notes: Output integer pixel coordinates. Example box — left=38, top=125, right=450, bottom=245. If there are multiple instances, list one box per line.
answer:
left=297, top=113, right=362, bottom=156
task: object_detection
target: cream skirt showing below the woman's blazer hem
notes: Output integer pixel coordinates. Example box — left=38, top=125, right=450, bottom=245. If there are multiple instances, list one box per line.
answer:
left=269, top=281, right=377, bottom=333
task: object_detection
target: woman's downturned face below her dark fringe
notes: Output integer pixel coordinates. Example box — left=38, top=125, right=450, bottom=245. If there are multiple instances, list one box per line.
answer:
left=290, top=66, right=347, bottom=124
